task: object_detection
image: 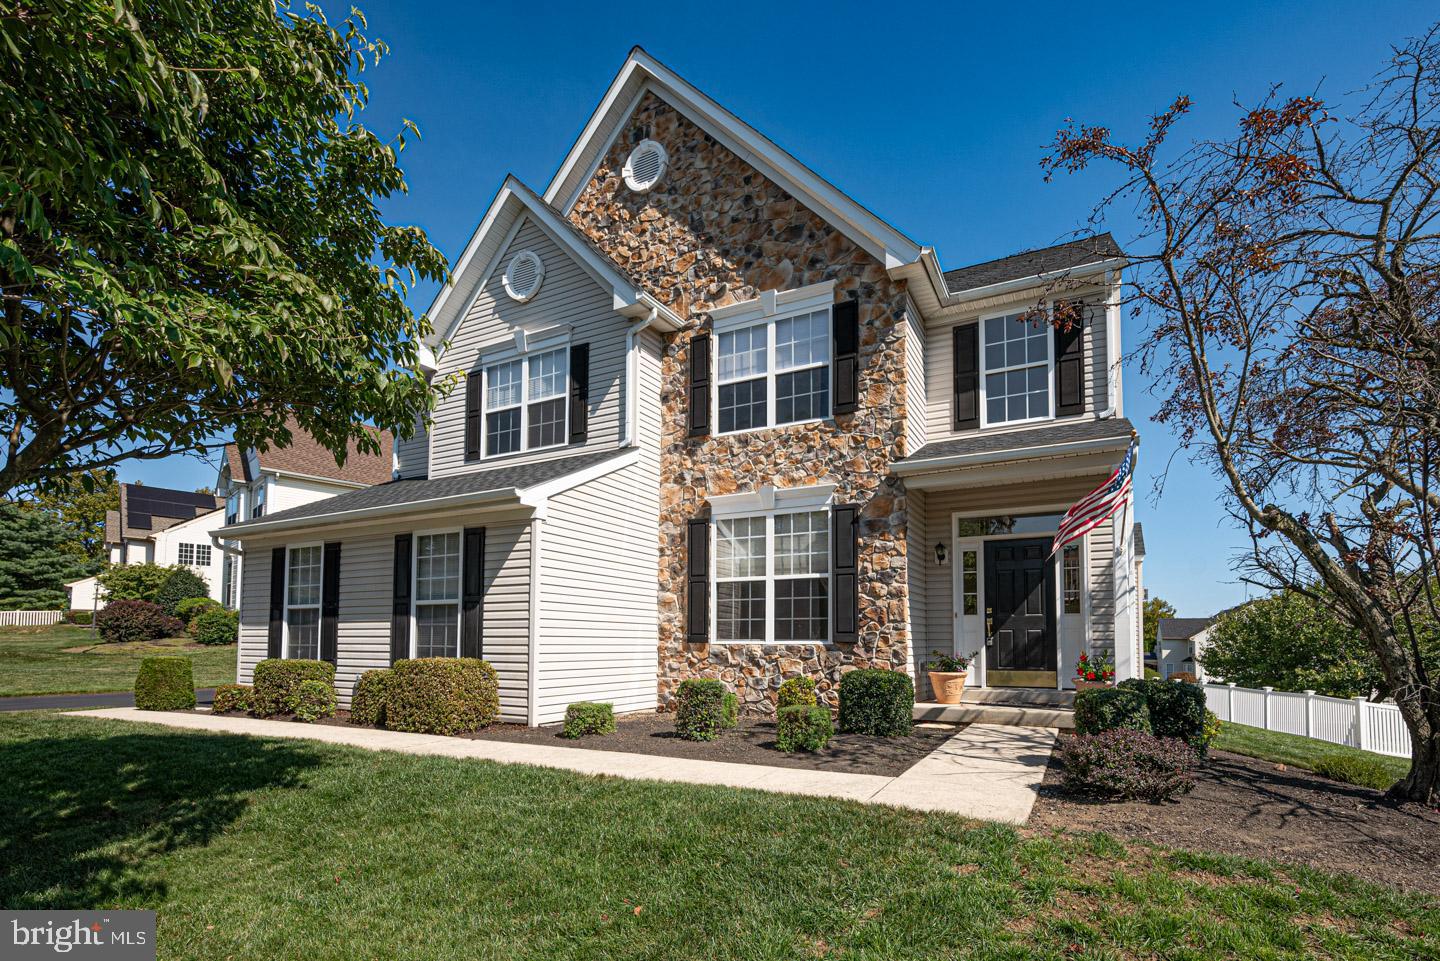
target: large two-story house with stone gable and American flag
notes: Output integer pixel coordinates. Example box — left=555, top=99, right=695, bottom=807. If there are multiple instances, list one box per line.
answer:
left=222, top=49, right=1140, bottom=723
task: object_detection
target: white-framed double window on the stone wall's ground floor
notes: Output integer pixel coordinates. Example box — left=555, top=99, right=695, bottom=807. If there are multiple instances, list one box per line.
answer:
left=714, top=507, right=831, bottom=644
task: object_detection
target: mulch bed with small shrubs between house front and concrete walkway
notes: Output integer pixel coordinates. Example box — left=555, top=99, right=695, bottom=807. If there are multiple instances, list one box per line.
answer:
left=469, top=715, right=965, bottom=777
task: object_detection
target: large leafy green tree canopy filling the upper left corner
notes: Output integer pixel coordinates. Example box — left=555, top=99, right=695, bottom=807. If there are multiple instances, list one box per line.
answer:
left=0, top=0, right=446, bottom=491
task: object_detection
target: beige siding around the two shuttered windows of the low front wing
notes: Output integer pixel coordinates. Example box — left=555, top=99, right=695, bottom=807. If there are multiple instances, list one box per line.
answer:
left=239, top=516, right=530, bottom=723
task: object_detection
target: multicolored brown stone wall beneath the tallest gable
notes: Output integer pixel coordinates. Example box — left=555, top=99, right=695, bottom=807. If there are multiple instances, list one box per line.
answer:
left=569, top=94, right=910, bottom=712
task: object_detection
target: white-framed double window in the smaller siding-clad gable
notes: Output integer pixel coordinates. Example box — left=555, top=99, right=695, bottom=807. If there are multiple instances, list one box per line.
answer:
left=482, top=346, right=570, bottom=457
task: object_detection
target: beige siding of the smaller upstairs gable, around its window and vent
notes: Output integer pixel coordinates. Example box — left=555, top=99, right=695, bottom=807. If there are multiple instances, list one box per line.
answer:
left=428, top=218, right=629, bottom=477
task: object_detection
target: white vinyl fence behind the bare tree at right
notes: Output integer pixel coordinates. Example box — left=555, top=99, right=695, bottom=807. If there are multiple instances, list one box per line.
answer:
left=1205, top=684, right=1410, bottom=758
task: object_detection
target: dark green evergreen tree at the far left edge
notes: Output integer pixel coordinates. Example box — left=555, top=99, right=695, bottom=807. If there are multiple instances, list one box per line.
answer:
left=0, top=501, right=89, bottom=611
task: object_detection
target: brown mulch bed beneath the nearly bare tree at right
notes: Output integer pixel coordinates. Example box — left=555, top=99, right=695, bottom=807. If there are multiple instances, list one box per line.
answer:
left=1030, top=751, right=1440, bottom=893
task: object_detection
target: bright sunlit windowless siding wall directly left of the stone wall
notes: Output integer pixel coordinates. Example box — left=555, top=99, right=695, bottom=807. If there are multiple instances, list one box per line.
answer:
left=536, top=331, right=661, bottom=723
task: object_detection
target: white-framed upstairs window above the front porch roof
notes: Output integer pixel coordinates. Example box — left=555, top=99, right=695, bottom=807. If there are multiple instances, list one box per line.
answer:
left=981, top=313, right=1054, bottom=426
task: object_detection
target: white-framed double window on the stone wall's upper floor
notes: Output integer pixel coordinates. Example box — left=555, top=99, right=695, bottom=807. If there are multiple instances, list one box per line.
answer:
left=716, top=307, right=831, bottom=434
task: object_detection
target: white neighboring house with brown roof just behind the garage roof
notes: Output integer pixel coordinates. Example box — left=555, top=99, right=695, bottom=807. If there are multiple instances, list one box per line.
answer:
left=215, top=419, right=395, bottom=608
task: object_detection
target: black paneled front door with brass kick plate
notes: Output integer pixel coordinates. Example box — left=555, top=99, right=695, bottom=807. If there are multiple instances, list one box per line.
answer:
left=985, top=537, right=1056, bottom=671
